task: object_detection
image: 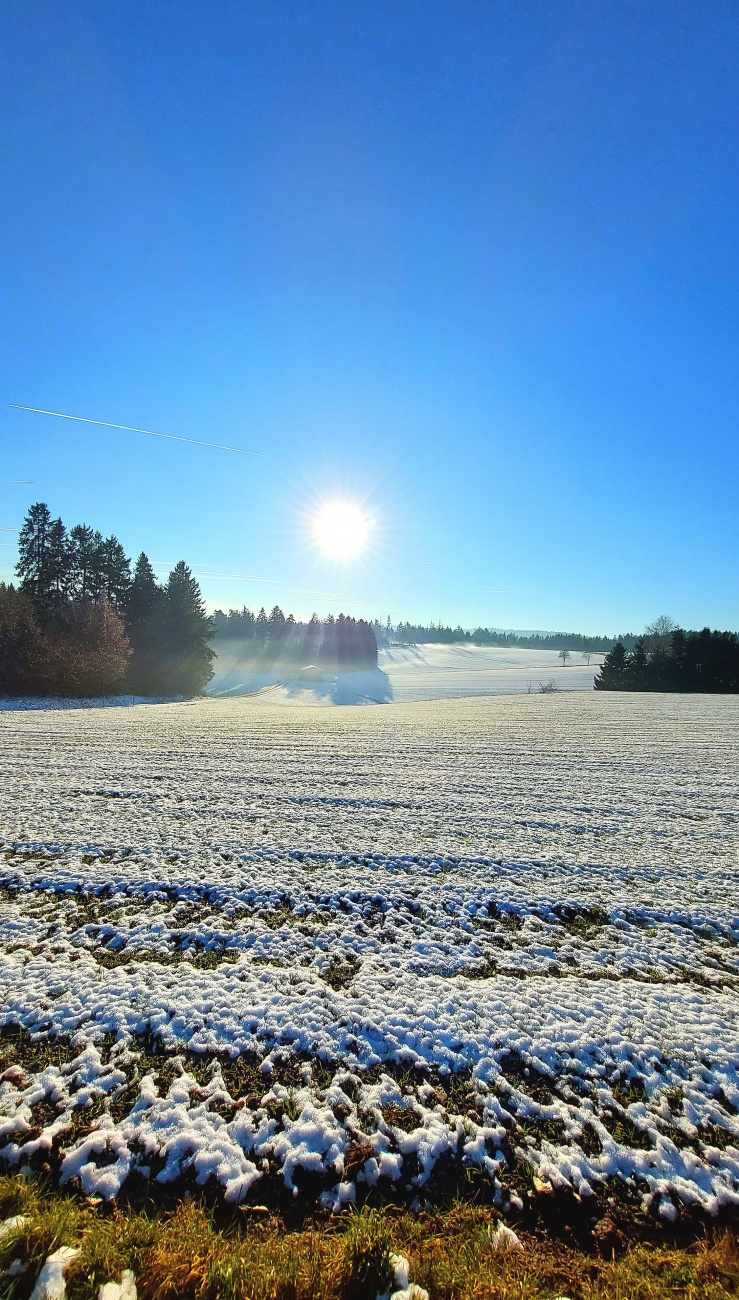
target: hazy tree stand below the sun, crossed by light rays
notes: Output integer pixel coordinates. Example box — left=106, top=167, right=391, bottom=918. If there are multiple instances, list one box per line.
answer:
left=213, top=605, right=377, bottom=672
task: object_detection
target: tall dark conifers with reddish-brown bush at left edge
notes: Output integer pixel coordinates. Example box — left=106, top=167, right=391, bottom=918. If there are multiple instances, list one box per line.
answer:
left=0, top=502, right=215, bottom=696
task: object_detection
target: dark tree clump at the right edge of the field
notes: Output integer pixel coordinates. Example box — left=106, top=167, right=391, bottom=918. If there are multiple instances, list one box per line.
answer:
left=595, top=627, right=739, bottom=694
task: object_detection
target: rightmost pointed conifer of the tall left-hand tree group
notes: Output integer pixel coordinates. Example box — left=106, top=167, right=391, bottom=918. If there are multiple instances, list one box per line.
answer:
left=164, top=560, right=215, bottom=696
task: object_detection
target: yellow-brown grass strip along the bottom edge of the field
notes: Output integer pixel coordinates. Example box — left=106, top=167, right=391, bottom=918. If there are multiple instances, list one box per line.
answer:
left=0, top=1177, right=739, bottom=1300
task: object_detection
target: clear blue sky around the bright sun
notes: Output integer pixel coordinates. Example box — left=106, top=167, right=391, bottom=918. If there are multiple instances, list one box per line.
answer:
left=0, top=0, right=739, bottom=632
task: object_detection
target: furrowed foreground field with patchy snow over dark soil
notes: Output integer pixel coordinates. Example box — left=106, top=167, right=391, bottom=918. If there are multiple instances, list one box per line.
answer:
left=0, top=696, right=739, bottom=1219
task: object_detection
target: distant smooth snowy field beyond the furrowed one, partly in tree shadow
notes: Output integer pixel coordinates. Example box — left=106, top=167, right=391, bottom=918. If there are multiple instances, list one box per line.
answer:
left=208, top=641, right=602, bottom=705
